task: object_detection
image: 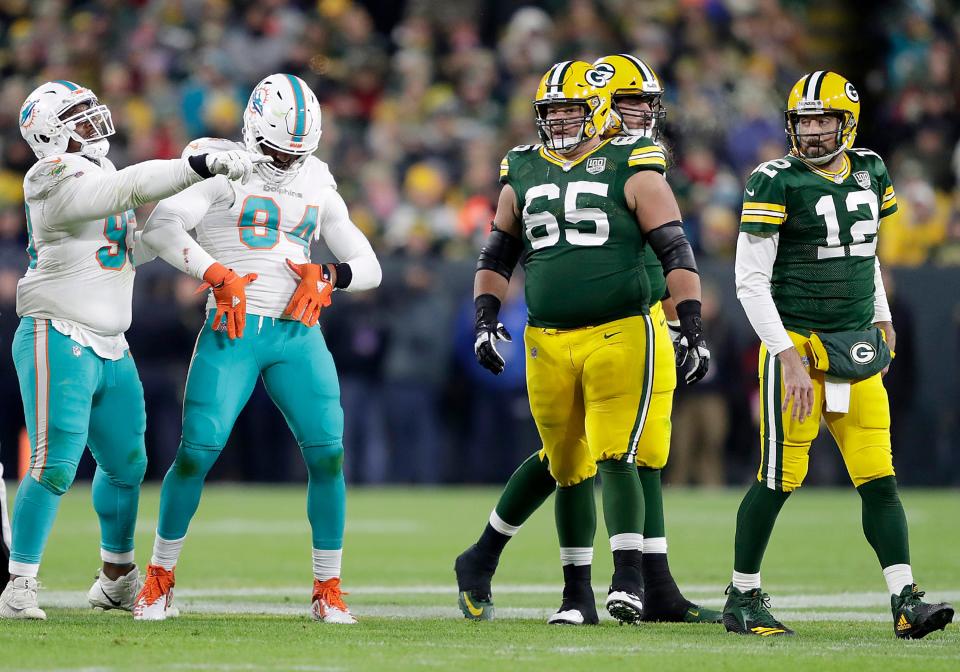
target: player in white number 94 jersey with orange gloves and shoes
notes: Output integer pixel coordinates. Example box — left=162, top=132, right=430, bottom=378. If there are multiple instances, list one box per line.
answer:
left=134, top=74, right=381, bottom=624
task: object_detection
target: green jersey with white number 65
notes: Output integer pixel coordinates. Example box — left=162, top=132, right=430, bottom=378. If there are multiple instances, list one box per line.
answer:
left=500, top=136, right=666, bottom=329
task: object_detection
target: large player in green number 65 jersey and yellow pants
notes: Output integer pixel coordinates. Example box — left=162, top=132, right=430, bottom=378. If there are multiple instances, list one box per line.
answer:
left=470, top=61, right=709, bottom=625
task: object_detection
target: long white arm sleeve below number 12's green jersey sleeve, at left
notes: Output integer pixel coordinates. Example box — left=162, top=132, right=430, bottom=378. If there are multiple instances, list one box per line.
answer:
left=736, top=232, right=793, bottom=355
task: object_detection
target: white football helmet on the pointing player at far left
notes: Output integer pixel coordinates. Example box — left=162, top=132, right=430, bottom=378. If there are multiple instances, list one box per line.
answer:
left=20, top=79, right=114, bottom=159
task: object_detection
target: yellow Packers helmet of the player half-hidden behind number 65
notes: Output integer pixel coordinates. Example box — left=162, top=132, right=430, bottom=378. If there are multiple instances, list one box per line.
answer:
left=593, top=54, right=667, bottom=141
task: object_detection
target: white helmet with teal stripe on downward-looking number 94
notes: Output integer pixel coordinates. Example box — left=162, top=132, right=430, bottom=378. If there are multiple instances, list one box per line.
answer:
left=243, top=73, right=320, bottom=184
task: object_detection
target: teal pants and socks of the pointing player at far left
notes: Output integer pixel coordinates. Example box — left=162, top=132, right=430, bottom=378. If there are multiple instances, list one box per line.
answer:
left=10, top=317, right=147, bottom=564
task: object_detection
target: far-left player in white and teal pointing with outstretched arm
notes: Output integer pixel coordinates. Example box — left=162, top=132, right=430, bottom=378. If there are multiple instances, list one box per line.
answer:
left=0, top=80, right=269, bottom=619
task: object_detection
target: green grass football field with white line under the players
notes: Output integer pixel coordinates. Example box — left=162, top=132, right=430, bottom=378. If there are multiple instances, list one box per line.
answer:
left=0, top=486, right=960, bottom=672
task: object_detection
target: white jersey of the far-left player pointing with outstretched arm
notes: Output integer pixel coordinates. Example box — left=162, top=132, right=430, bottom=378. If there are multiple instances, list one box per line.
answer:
left=17, top=154, right=201, bottom=359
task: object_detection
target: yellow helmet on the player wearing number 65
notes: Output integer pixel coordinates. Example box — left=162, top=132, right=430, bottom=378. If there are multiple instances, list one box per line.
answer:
left=533, top=61, right=610, bottom=152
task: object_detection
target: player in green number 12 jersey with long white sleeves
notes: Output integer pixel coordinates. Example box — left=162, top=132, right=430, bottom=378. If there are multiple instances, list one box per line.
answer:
left=723, top=70, right=953, bottom=639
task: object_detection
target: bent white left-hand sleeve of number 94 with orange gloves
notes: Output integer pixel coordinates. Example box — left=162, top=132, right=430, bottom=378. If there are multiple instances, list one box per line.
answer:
left=141, top=177, right=232, bottom=280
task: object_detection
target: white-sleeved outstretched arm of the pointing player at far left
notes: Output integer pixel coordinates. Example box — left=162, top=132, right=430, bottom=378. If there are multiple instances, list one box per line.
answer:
left=43, top=159, right=203, bottom=229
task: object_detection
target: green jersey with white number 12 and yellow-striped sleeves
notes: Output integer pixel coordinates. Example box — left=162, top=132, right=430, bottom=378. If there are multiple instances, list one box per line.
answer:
left=740, top=149, right=897, bottom=332
